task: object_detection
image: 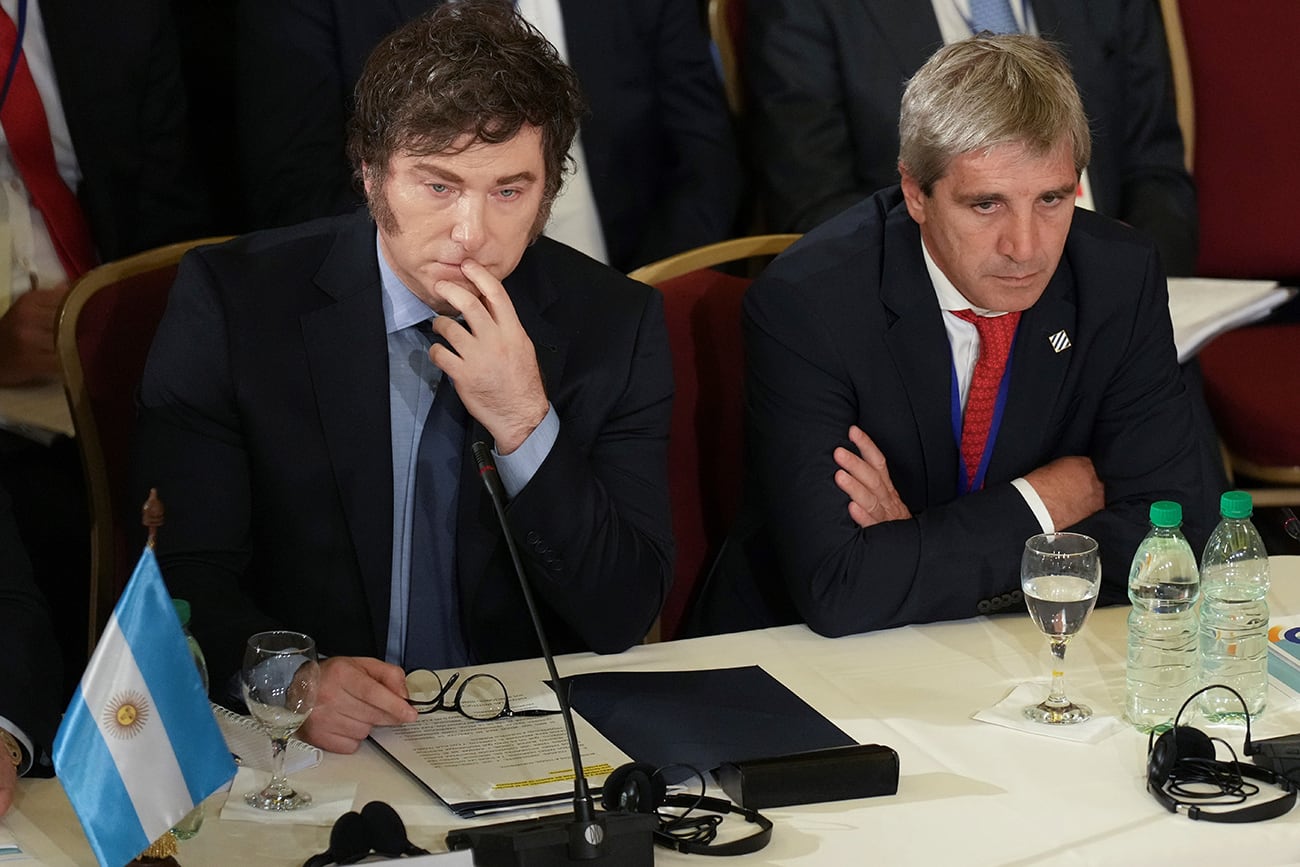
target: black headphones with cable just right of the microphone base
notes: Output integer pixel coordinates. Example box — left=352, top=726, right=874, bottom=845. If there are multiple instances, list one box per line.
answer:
left=601, top=762, right=772, bottom=855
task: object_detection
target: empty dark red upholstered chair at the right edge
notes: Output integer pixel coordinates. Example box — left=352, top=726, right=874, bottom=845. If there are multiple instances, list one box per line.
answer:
left=1180, top=0, right=1300, bottom=506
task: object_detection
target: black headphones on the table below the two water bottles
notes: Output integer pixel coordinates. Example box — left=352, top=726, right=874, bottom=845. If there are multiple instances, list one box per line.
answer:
left=1147, top=684, right=1296, bottom=823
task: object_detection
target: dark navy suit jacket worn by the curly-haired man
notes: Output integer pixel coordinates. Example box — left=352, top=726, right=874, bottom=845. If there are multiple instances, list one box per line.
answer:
left=135, top=209, right=672, bottom=684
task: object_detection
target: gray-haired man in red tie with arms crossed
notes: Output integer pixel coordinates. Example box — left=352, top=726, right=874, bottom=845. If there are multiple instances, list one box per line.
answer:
left=697, top=35, right=1217, bottom=636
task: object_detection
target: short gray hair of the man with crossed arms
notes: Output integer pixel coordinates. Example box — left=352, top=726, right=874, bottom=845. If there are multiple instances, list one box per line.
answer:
left=898, top=34, right=1092, bottom=196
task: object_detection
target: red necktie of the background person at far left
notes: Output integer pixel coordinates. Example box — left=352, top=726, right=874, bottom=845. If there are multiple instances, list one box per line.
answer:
left=0, top=10, right=95, bottom=279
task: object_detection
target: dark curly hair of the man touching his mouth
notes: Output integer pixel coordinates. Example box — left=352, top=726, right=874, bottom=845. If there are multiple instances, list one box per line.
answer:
left=347, top=0, right=585, bottom=222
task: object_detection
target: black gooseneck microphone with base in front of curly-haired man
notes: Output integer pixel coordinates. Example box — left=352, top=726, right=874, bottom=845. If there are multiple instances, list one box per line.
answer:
left=447, top=442, right=658, bottom=867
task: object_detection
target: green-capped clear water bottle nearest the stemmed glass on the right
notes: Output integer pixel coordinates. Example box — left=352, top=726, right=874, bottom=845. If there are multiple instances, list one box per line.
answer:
left=1125, top=500, right=1200, bottom=732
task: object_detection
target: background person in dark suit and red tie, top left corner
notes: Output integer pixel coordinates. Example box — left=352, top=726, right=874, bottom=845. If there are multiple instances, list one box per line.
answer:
left=0, top=0, right=209, bottom=385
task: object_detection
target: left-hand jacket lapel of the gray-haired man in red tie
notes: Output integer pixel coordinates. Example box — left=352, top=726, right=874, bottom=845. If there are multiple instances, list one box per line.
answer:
left=880, top=203, right=957, bottom=503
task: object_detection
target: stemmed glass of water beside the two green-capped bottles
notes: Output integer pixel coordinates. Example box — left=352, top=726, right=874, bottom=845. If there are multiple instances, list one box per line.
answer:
left=1021, top=533, right=1101, bottom=725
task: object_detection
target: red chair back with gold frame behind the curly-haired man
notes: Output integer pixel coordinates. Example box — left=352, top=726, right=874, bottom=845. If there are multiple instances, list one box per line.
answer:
left=56, top=238, right=233, bottom=649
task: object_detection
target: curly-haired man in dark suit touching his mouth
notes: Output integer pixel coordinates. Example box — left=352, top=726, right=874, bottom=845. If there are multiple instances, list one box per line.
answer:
left=137, top=3, right=672, bottom=751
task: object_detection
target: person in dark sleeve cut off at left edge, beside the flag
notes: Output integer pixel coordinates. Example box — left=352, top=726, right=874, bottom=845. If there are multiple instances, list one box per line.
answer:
left=0, top=487, right=64, bottom=816
